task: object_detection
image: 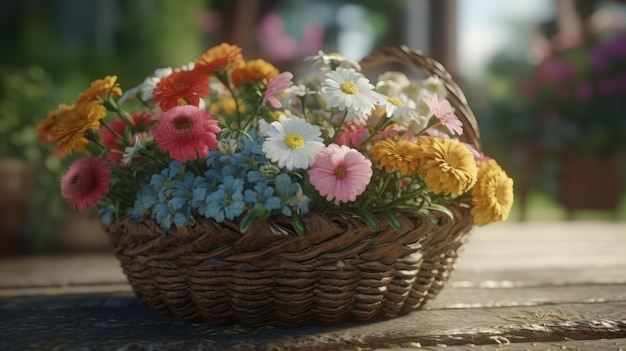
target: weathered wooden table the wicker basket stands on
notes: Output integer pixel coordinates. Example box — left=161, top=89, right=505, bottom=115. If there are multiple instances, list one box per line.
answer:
left=0, top=222, right=626, bottom=350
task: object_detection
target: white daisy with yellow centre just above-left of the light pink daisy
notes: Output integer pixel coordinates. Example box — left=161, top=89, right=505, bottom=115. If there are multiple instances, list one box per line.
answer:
left=263, top=114, right=324, bottom=170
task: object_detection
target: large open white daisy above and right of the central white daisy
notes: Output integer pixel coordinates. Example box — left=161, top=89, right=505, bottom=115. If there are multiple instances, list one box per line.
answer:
left=322, top=68, right=381, bottom=117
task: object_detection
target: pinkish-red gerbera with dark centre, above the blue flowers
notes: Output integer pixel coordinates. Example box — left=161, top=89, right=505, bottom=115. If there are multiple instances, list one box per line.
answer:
left=154, top=105, right=220, bottom=162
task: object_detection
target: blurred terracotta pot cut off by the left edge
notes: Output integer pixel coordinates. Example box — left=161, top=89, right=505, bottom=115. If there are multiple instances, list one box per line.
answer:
left=0, top=158, right=34, bottom=255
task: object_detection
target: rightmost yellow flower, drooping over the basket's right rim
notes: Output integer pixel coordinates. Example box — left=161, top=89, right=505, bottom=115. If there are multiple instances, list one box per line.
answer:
left=472, top=159, right=514, bottom=226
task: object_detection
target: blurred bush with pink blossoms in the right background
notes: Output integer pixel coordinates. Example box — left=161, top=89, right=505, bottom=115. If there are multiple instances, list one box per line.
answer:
left=523, top=33, right=626, bottom=155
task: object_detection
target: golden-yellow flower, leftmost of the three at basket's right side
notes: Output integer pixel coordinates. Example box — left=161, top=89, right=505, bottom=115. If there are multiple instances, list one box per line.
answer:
left=370, top=139, right=419, bottom=175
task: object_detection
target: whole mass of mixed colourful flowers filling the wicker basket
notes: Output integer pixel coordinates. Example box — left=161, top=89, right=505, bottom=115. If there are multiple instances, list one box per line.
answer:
left=37, top=43, right=513, bottom=234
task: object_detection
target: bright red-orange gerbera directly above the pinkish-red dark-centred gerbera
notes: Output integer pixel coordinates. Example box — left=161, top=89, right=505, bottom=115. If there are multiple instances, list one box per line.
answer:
left=152, top=70, right=211, bottom=111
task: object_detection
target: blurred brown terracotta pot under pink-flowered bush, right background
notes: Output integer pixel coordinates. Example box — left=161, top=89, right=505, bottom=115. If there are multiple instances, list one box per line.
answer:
left=558, top=156, right=621, bottom=210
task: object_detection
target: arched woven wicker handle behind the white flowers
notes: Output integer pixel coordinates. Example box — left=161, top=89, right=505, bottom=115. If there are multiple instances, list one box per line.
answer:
left=360, top=45, right=482, bottom=151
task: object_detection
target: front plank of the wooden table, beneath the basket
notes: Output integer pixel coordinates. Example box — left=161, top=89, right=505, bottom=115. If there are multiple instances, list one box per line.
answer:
left=0, top=295, right=626, bottom=350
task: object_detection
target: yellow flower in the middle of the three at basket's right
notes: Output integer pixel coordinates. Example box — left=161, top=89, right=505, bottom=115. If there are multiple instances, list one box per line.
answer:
left=417, top=138, right=478, bottom=195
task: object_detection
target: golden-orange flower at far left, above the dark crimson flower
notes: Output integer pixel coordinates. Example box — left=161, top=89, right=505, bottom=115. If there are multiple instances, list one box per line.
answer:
left=52, top=101, right=106, bottom=154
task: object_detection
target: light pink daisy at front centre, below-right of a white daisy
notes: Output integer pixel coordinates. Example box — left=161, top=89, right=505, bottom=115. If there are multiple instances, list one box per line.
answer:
left=309, top=144, right=372, bottom=202
